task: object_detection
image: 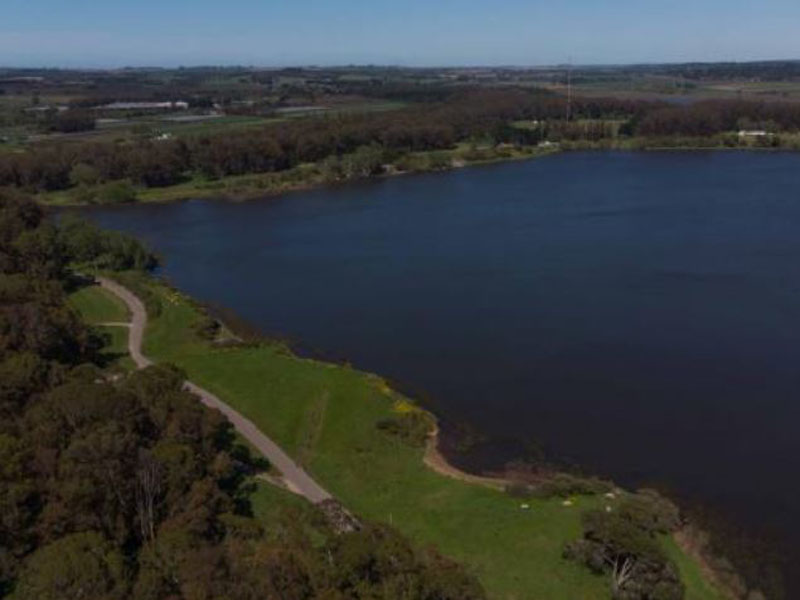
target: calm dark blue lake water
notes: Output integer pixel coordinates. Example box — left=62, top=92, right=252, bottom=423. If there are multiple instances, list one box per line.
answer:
left=78, top=152, right=800, bottom=592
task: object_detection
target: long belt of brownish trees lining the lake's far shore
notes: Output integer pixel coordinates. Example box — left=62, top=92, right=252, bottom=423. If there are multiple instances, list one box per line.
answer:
left=0, top=89, right=800, bottom=196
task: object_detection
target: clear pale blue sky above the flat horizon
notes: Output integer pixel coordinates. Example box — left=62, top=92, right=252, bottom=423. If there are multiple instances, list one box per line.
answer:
left=0, top=0, right=800, bottom=67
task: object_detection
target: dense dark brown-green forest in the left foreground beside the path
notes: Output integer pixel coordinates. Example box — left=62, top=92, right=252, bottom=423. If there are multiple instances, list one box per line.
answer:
left=0, top=192, right=484, bottom=600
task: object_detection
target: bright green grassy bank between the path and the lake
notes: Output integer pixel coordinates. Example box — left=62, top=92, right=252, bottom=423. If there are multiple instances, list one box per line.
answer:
left=73, top=283, right=718, bottom=600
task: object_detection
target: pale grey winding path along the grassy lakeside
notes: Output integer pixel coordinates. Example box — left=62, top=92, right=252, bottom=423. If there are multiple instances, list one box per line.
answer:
left=96, top=277, right=333, bottom=504
